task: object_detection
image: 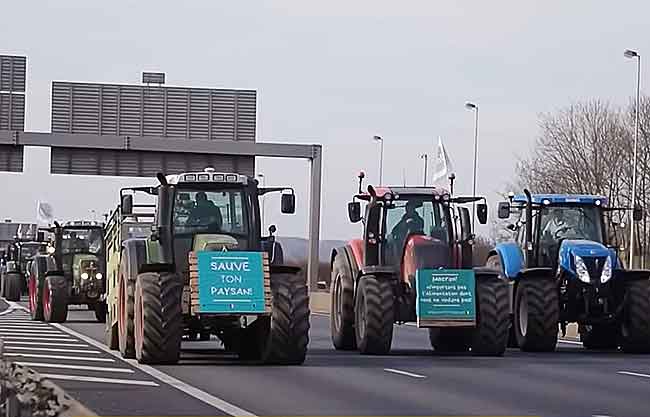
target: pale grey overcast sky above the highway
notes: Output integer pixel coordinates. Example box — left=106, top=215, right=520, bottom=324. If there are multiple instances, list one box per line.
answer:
left=0, top=0, right=650, bottom=239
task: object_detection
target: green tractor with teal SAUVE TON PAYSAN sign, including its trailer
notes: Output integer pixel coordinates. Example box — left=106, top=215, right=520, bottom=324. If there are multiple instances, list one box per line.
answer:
left=106, top=168, right=310, bottom=365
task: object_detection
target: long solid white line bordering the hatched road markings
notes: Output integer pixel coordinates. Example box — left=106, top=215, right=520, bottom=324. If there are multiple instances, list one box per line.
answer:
left=53, top=323, right=257, bottom=417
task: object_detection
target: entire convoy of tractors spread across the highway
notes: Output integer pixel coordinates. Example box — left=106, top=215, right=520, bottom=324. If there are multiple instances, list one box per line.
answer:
left=1, top=164, right=650, bottom=365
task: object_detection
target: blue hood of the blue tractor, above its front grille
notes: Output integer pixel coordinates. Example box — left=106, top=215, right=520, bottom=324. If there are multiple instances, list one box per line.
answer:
left=559, top=240, right=618, bottom=280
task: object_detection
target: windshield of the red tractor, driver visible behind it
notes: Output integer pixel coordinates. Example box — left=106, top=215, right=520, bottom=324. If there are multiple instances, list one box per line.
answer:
left=386, top=198, right=449, bottom=259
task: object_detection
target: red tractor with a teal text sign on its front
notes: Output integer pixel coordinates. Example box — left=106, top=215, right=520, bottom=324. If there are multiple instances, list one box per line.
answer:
left=330, top=173, right=509, bottom=356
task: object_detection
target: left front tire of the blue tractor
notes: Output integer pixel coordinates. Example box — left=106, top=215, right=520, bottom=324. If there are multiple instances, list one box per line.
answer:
left=514, top=278, right=560, bottom=352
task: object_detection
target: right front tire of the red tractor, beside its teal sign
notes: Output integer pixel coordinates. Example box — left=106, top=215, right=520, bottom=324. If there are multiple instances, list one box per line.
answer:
left=471, top=278, right=510, bottom=356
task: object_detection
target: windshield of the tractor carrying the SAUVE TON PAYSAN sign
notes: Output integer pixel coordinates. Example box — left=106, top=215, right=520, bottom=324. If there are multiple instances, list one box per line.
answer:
left=173, top=190, right=248, bottom=236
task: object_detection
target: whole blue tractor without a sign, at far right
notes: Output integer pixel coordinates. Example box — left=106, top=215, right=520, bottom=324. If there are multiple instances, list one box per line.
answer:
left=486, top=190, right=650, bottom=353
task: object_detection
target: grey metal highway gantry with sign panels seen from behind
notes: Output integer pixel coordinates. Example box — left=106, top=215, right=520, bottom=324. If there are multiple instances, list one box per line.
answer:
left=0, top=57, right=322, bottom=288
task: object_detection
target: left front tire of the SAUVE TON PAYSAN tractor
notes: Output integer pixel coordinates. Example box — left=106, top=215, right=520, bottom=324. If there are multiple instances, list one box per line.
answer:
left=134, top=272, right=183, bottom=365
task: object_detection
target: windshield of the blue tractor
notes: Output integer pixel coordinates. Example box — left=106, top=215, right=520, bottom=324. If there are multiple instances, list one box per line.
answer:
left=540, top=205, right=603, bottom=243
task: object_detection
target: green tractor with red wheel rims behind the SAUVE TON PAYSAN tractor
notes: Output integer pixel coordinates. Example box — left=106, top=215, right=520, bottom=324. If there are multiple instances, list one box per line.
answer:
left=27, top=221, right=106, bottom=323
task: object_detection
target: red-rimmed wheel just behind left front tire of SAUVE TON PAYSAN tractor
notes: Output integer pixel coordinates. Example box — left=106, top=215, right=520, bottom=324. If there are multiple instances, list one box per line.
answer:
left=117, top=252, right=135, bottom=359
